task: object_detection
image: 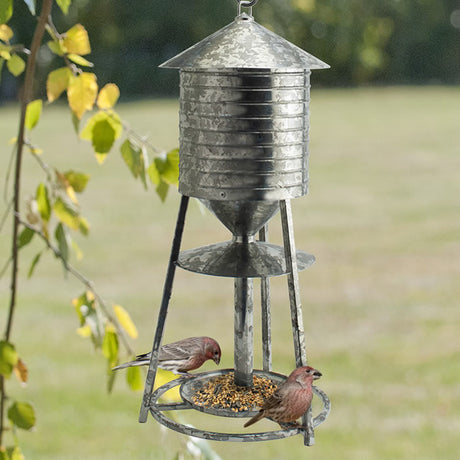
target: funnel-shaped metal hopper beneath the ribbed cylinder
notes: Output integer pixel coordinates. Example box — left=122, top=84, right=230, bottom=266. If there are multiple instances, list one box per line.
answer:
left=201, top=200, right=279, bottom=236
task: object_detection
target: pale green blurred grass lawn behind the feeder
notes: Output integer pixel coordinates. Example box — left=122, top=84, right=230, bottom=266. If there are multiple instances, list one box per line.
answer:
left=0, top=85, right=460, bottom=460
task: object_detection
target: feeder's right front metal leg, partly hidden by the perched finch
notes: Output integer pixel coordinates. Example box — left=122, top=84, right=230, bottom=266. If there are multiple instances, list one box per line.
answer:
left=280, top=200, right=315, bottom=446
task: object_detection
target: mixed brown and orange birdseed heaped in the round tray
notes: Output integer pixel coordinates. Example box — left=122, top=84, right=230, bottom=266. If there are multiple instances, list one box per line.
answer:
left=191, top=372, right=277, bottom=412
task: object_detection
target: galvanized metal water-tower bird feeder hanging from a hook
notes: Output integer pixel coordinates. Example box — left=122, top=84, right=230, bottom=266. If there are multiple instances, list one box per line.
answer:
left=139, top=0, right=330, bottom=445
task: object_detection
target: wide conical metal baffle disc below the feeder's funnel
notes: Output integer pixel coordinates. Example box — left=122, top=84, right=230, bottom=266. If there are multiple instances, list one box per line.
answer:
left=177, top=239, right=315, bottom=278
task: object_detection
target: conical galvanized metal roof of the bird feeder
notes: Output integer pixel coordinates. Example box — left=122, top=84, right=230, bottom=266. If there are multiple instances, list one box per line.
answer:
left=160, top=13, right=329, bottom=69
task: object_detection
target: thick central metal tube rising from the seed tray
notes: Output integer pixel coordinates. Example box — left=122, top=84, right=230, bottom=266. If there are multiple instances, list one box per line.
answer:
left=234, top=278, right=254, bottom=387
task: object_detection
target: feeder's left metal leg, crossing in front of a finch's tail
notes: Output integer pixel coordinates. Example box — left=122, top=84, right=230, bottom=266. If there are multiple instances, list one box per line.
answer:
left=139, top=196, right=189, bottom=423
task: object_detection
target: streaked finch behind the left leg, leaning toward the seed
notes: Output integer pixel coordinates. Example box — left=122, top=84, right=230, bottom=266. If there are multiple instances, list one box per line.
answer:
left=112, top=337, right=221, bottom=374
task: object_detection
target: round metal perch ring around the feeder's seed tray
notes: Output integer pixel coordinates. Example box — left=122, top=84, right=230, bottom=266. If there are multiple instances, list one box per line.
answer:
left=146, top=369, right=330, bottom=442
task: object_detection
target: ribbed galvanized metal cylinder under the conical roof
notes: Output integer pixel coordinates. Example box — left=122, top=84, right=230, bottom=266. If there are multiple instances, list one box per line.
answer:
left=179, top=69, right=310, bottom=201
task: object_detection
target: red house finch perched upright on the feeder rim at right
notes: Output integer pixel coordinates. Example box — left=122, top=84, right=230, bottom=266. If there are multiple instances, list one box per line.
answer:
left=244, top=366, right=322, bottom=428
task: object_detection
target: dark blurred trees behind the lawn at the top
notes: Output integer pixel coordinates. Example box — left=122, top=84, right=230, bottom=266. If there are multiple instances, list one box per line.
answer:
left=0, top=0, right=460, bottom=101
